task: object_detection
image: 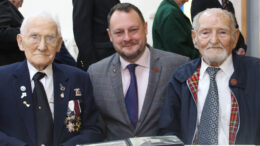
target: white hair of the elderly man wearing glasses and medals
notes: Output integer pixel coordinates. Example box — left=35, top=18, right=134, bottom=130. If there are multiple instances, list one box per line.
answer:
left=20, top=11, right=61, bottom=36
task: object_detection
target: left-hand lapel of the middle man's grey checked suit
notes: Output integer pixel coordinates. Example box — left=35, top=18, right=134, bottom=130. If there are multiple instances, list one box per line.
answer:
left=110, top=53, right=134, bottom=128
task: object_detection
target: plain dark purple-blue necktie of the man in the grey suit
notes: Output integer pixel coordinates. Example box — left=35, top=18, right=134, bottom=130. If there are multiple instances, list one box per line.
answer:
left=125, top=64, right=138, bottom=126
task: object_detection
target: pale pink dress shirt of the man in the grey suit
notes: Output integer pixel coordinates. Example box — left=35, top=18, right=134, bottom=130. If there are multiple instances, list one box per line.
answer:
left=120, top=47, right=150, bottom=118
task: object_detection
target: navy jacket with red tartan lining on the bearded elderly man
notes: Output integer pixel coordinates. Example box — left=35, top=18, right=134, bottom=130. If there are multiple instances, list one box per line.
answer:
left=159, top=54, right=260, bottom=144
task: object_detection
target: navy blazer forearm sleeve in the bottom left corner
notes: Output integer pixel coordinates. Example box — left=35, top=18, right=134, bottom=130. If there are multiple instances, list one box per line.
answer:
left=0, top=131, right=26, bottom=146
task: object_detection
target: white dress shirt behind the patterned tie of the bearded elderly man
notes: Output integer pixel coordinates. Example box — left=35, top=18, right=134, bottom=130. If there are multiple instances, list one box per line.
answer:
left=196, top=55, right=234, bottom=145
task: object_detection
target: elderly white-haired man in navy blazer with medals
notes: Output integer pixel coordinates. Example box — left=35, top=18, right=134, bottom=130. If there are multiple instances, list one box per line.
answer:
left=0, top=12, right=103, bottom=146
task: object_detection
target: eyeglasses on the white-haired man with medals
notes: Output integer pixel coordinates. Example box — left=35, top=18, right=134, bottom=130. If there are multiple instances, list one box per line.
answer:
left=22, top=34, right=58, bottom=44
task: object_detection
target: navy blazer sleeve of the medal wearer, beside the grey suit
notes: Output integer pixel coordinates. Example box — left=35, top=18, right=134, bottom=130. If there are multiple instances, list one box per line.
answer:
left=63, top=73, right=104, bottom=146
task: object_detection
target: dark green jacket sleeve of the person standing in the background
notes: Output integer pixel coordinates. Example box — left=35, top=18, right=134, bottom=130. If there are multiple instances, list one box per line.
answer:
left=160, top=11, right=199, bottom=59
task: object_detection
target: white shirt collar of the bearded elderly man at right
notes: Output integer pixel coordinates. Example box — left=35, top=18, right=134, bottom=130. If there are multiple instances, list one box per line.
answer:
left=200, top=54, right=234, bottom=79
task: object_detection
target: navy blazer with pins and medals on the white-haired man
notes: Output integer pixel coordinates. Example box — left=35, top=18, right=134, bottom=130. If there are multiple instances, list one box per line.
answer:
left=0, top=61, right=103, bottom=146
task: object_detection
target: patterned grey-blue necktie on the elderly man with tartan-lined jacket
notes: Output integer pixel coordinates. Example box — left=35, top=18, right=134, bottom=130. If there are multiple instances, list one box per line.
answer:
left=197, top=67, right=220, bottom=145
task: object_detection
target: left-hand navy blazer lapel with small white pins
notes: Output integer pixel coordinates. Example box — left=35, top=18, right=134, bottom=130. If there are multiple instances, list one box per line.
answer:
left=13, top=61, right=35, bottom=144
